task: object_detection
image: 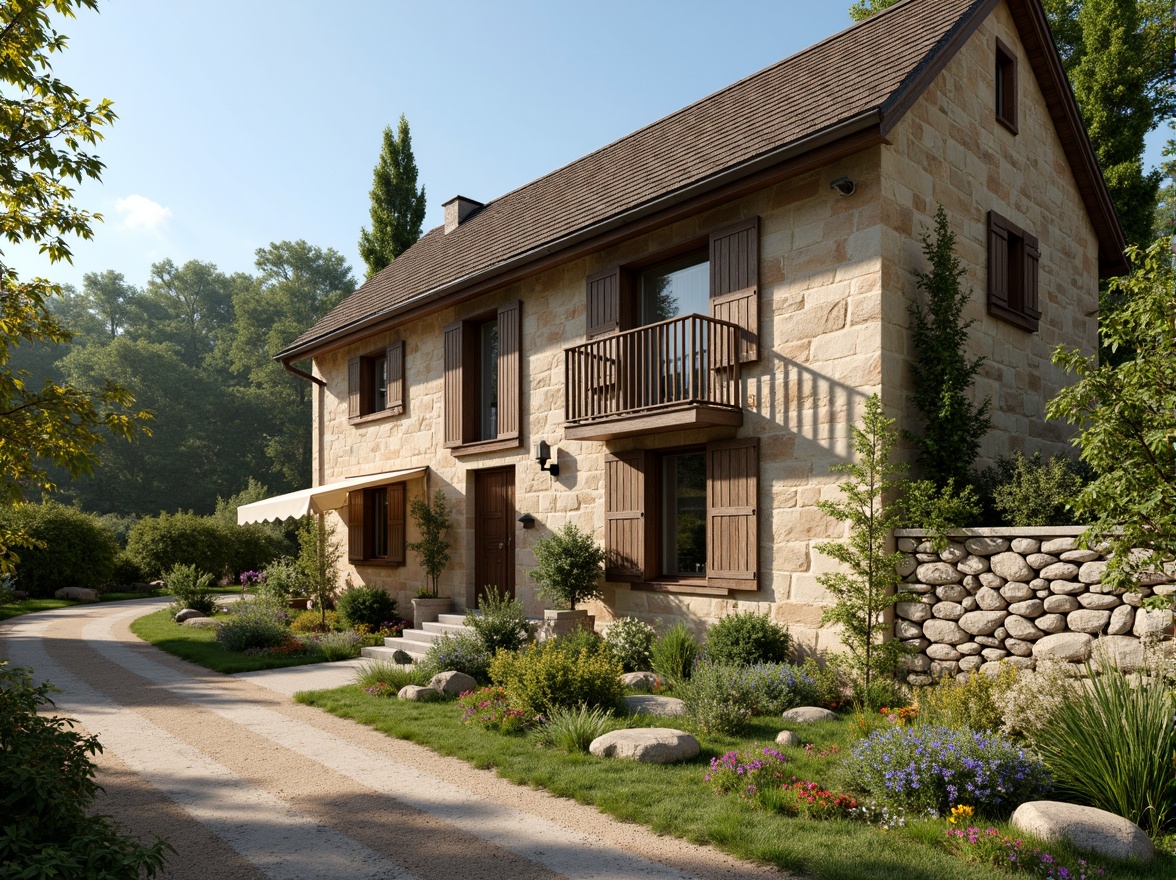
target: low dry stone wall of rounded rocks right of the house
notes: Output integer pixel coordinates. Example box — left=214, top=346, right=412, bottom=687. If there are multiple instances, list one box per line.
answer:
left=895, top=528, right=1176, bottom=685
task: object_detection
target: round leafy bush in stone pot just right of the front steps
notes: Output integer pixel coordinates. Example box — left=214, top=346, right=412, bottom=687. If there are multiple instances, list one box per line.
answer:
left=528, top=522, right=604, bottom=635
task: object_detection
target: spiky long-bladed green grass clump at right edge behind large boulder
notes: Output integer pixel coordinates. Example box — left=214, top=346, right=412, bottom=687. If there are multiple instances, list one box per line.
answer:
left=1036, top=666, right=1176, bottom=836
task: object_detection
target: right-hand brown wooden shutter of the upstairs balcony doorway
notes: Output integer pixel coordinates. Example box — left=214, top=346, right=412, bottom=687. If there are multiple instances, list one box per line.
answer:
left=710, top=216, right=760, bottom=364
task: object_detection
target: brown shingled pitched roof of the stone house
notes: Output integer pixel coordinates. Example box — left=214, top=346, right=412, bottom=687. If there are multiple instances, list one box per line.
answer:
left=278, top=0, right=1122, bottom=361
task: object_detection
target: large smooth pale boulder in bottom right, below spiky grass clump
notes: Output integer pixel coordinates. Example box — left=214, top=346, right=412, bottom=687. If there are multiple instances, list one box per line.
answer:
left=1011, top=800, right=1156, bottom=861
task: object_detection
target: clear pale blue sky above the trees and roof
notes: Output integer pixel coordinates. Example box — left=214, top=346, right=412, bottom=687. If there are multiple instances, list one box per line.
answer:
left=5, top=0, right=1165, bottom=286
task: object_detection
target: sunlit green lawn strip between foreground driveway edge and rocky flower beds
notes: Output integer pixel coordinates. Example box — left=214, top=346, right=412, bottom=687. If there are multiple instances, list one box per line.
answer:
left=295, top=686, right=1176, bottom=880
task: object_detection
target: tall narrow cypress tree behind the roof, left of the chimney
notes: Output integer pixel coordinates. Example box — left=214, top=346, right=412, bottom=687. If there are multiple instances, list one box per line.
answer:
left=360, top=114, right=425, bottom=278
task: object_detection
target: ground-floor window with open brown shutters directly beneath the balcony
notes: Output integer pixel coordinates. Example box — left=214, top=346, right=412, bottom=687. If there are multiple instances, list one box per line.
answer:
left=604, top=438, right=759, bottom=591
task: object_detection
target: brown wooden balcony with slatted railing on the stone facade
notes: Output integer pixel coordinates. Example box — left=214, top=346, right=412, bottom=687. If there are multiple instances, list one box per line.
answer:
left=563, top=314, right=743, bottom=440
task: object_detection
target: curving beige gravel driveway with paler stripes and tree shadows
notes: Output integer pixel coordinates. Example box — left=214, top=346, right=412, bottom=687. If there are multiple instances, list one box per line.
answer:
left=0, top=599, right=781, bottom=880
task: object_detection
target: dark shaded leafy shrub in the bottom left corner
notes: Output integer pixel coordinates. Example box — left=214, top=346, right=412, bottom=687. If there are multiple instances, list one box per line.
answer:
left=0, top=662, right=174, bottom=880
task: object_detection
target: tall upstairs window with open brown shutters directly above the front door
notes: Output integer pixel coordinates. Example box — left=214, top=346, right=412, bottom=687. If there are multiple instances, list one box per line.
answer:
left=443, top=301, right=522, bottom=454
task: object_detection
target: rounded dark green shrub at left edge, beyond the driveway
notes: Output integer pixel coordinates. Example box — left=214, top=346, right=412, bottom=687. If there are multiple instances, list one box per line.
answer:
left=0, top=501, right=119, bottom=599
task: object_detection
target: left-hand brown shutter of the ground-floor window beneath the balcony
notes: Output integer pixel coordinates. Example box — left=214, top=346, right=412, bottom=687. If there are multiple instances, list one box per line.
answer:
left=604, top=449, right=649, bottom=581
